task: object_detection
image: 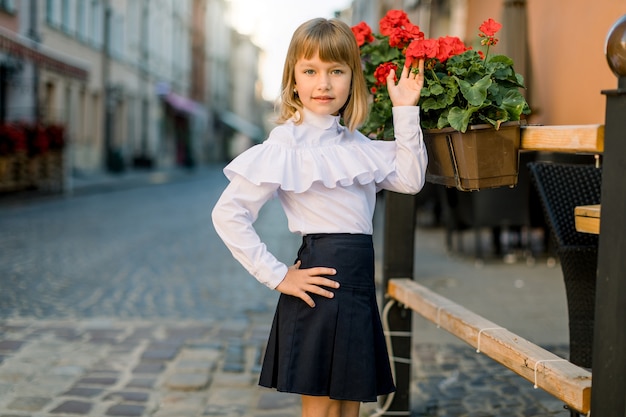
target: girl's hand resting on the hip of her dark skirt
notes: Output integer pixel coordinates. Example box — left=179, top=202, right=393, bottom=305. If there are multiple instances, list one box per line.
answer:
left=276, top=261, right=339, bottom=307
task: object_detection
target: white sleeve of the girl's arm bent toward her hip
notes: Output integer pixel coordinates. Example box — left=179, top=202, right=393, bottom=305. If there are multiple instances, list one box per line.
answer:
left=212, top=176, right=287, bottom=289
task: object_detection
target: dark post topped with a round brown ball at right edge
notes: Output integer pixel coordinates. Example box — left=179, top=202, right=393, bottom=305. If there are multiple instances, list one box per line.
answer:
left=591, top=15, right=626, bottom=417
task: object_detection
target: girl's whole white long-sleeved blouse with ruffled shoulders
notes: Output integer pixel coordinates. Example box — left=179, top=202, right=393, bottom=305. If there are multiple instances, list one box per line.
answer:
left=212, top=106, right=428, bottom=289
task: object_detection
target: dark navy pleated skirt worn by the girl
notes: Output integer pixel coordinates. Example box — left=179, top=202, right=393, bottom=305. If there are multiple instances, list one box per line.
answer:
left=259, top=234, right=395, bottom=402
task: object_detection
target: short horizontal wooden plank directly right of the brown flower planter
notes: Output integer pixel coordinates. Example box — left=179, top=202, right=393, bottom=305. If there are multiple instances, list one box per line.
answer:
left=520, top=124, right=604, bottom=153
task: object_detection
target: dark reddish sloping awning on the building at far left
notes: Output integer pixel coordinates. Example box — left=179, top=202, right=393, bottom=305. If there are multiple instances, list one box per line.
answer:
left=0, top=29, right=89, bottom=81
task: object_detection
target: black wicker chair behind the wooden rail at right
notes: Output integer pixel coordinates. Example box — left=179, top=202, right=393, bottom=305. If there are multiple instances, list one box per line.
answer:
left=528, top=162, right=602, bottom=369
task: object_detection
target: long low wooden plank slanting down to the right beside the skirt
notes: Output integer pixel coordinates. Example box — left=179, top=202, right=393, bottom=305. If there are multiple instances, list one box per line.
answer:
left=388, top=279, right=591, bottom=414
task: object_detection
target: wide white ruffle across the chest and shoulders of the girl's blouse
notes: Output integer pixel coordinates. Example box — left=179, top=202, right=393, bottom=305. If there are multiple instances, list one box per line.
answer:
left=224, top=128, right=395, bottom=193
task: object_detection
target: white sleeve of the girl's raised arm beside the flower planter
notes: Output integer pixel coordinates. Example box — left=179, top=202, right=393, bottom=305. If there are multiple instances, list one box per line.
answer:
left=373, top=106, right=428, bottom=194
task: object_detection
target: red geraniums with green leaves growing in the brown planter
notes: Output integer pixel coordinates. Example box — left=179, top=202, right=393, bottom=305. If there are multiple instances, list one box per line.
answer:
left=352, top=10, right=530, bottom=139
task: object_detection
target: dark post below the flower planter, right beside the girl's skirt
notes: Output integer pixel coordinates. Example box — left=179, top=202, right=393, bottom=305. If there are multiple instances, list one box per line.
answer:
left=382, top=192, right=415, bottom=416
